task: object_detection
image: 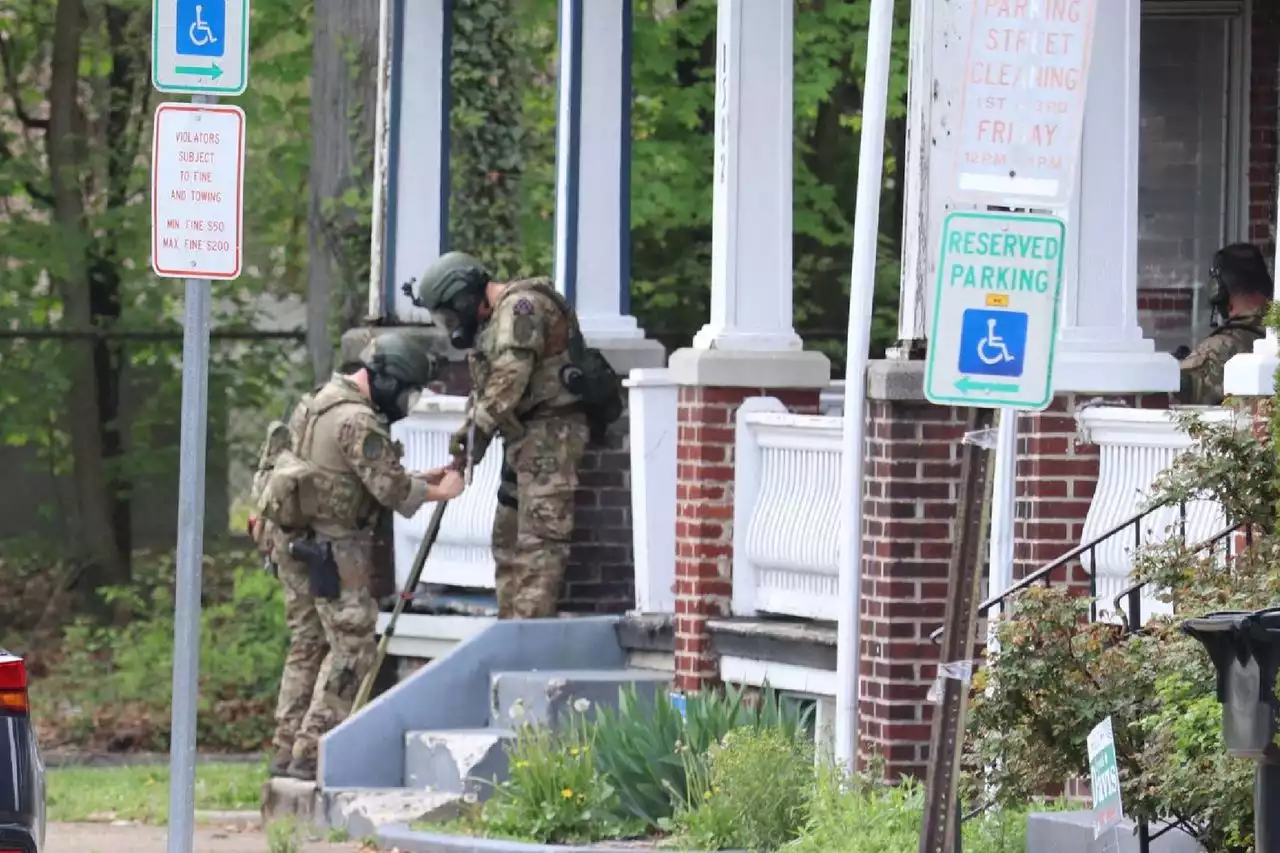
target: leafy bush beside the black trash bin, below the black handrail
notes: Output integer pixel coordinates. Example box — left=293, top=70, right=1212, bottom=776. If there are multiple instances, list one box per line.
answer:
left=969, top=540, right=1280, bottom=853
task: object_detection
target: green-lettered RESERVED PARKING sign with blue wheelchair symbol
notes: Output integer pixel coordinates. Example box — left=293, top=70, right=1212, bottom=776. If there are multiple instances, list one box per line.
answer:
left=924, top=213, right=1066, bottom=411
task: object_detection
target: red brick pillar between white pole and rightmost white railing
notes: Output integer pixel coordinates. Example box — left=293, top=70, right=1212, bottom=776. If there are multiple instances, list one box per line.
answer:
left=1014, top=393, right=1170, bottom=584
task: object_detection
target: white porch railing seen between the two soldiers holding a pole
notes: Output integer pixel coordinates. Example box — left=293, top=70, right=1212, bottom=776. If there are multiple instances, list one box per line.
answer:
left=392, top=394, right=502, bottom=589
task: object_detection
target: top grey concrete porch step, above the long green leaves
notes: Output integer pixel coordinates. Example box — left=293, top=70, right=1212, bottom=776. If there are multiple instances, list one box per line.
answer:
left=489, top=669, right=671, bottom=727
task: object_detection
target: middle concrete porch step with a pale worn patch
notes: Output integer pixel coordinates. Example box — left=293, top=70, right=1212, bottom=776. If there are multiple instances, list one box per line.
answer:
left=404, top=729, right=516, bottom=800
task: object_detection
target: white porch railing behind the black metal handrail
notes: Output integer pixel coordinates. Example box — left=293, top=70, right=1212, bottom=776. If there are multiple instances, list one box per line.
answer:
left=1076, top=406, right=1231, bottom=621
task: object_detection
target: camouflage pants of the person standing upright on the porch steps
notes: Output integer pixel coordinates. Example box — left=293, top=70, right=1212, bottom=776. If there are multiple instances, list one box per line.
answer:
left=493, top=415, right=589, bottom=619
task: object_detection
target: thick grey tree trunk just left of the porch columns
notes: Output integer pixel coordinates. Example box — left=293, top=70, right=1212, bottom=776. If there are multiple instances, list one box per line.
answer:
left=307, top=0, right=378, bottom=380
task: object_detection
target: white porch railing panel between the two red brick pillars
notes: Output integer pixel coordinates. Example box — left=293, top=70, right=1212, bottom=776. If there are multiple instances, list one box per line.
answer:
left=733, top=397, right=842, bottom=621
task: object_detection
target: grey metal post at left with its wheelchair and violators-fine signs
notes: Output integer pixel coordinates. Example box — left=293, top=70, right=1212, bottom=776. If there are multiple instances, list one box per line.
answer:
left=151, top=0, right=250, bottom=853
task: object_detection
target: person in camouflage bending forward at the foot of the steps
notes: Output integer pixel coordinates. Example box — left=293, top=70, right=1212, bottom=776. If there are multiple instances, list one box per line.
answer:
left=255, top=333, right=462, bottom=780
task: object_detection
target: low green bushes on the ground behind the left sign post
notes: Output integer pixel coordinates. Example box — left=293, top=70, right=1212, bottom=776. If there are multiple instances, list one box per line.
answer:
left=32, top=551, right=288, bottom=751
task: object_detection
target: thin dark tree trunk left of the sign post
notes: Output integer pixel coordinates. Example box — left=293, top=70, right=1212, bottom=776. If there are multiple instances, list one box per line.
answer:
left=46, top=0, right=128, bottom=604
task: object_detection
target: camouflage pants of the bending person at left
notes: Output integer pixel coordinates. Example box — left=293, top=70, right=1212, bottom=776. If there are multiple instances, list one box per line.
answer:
left=273, top=534, right=378, bottom=758
